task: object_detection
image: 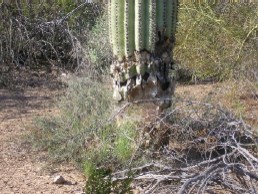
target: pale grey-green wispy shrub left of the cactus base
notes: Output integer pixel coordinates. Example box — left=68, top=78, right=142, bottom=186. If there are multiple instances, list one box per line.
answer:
left=30, top=78, right=112, bottom=162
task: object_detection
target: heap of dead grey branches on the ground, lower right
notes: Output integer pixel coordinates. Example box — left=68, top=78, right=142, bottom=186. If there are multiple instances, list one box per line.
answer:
left=112, top=100, right=258, bottom=194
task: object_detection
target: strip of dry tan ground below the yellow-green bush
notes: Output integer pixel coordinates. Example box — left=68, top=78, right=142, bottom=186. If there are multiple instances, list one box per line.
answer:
left=176, top=81, right=258, bottom=126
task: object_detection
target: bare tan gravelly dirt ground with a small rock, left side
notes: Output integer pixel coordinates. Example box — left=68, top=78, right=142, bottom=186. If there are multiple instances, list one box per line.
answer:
left=0, top=88, right=85, bottom=194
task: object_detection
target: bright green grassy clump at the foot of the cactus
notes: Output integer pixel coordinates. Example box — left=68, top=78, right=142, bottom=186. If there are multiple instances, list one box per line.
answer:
left=84, top=121, right=138, bottom=173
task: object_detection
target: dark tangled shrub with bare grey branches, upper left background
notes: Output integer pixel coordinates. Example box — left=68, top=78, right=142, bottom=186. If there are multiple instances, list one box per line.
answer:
left=0, top=0, right=103, bottom=88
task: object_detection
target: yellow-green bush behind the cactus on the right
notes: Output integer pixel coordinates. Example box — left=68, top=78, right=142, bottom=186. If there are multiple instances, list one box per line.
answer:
left=174, top=2, right=258, bottom=80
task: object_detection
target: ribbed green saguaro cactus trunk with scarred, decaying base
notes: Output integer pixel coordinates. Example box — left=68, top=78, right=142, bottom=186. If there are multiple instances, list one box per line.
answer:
left=109, top=0, right=178, bottom=106
